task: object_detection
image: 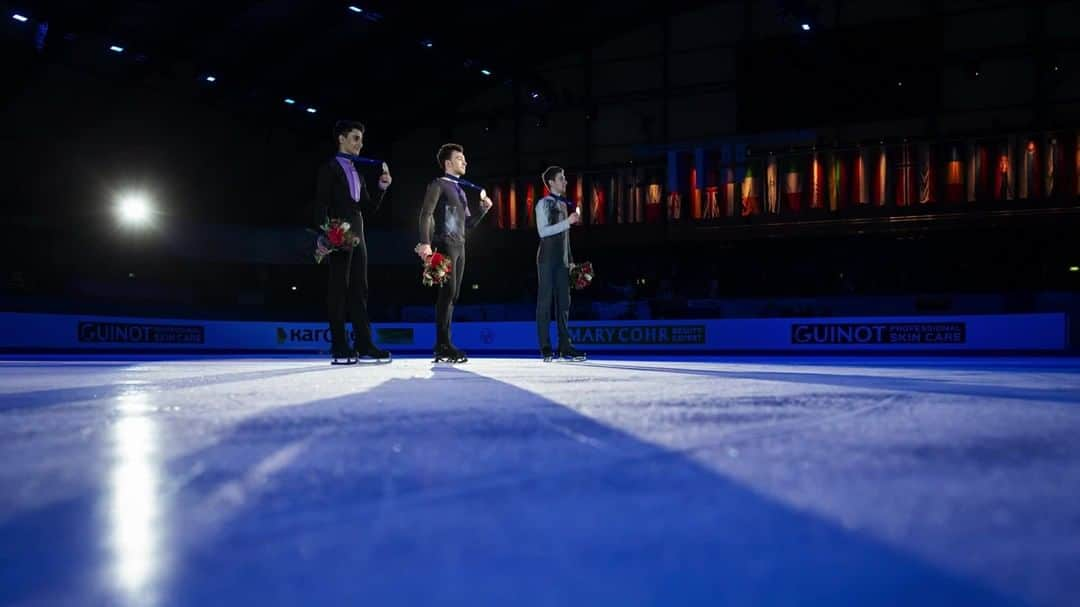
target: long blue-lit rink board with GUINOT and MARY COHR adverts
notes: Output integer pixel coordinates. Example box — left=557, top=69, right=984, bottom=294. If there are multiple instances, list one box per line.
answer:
left=0, top=312, right=1068, bottom=353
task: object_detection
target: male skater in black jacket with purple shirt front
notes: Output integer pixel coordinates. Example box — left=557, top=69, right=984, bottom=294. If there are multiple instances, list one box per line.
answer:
left=315, top=121, right=391, bottom=365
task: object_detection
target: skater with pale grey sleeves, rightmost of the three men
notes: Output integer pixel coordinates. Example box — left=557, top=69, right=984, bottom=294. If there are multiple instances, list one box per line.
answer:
left=536, top=166, right=585, bottom=362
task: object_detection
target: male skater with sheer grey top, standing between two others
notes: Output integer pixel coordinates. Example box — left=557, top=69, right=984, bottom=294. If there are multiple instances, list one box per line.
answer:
left=414, top=144, right=491, bottom=363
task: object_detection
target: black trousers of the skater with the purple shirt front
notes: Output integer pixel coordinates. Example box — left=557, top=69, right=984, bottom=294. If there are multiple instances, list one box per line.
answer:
left=326, top=240, right=373, bottom=356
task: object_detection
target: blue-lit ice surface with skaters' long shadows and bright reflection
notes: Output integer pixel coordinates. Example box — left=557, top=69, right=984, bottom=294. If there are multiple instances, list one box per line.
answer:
left=0, top=355, right=1080, bottom=606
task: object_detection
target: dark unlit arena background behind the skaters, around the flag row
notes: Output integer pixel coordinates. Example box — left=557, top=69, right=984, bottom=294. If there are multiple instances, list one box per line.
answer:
left=0, top=0, right=1080, bottom=320
